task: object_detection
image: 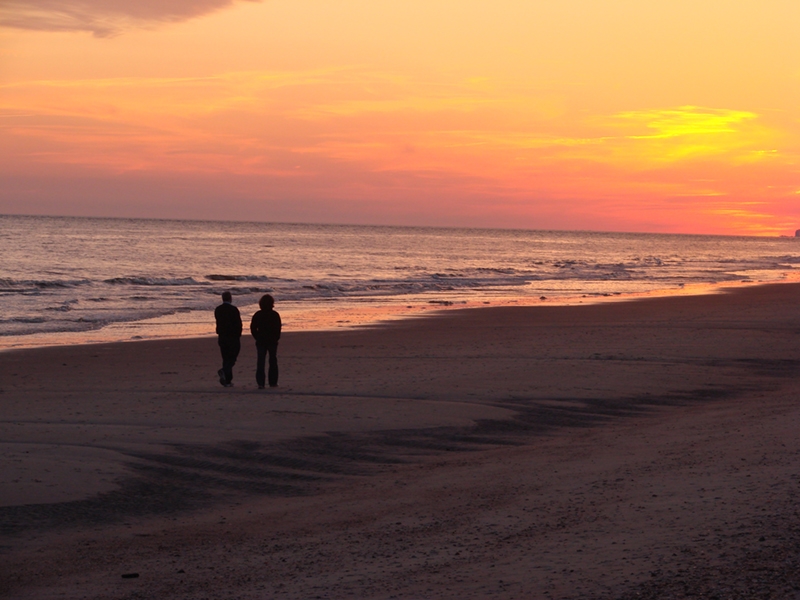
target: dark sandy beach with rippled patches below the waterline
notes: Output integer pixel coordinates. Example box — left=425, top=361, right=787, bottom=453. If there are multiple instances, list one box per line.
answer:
left=0, top=284, right=800, bottom=599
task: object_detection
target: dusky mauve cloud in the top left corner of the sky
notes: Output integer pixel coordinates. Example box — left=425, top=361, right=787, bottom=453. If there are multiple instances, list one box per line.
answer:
left=0, top=0, right=261, bottom=37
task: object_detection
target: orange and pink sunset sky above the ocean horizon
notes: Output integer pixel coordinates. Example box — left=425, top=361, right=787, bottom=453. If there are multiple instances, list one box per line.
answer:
left=0, top=0, right=800, bottom=235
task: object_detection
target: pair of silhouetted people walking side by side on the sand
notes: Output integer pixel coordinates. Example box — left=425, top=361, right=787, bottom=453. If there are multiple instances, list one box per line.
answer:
left=214, top=292, right=281, bottom=390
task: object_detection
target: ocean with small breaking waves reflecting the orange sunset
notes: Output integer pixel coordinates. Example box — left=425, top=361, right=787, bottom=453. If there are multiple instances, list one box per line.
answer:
left=0, top=216, right=800, bottom=349
